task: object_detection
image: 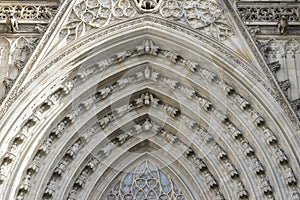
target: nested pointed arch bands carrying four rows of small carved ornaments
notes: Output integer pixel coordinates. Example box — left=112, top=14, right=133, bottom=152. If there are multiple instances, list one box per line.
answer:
left=0, top=36, right=299, bottom=200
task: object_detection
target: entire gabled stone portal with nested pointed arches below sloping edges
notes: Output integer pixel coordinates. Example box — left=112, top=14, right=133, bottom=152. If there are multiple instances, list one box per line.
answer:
left=0, top=0, right=300, bottom=200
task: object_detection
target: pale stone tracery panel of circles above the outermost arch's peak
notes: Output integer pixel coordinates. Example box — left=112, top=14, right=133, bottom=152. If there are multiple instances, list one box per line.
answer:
left=62, top=0, right=233, bottom=41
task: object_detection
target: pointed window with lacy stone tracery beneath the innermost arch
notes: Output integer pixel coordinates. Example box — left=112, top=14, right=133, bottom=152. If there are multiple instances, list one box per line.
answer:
left=107, top=160, right=185, bottom=200
